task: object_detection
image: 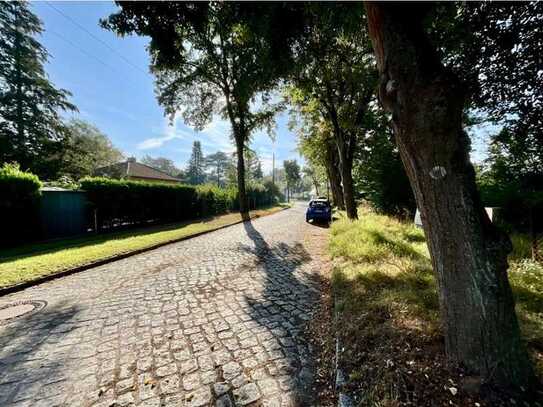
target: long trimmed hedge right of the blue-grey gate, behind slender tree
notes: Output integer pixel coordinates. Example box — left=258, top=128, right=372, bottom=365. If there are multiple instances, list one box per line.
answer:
left=80, top=177, right=275, bottom=229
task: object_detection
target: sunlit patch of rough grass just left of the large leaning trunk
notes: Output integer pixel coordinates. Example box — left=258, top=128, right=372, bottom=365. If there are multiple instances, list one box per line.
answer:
left=330, top=210, right=439, bottom=329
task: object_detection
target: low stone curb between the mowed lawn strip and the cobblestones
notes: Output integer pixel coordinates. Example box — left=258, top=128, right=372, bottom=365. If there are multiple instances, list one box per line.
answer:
left=0, top=206, right=291, bottom=298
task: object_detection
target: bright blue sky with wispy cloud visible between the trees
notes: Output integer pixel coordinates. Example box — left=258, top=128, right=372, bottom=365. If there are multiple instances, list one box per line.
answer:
left=31, top=2, right=301, bottom=172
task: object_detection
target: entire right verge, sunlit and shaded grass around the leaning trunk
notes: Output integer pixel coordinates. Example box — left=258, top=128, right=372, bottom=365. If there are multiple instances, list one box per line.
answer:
left=330, top=209, right=543, bottom=406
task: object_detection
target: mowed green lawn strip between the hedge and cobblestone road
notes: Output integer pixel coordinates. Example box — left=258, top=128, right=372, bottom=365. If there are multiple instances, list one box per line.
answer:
left=0, top=205, right=285, bottom=288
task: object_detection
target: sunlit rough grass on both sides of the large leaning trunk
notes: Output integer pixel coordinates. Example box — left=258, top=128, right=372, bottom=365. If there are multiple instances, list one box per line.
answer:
left=330, top=208, right=543, bottom=390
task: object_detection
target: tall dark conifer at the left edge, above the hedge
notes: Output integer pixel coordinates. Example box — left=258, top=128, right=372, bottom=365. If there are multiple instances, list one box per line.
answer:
left=0, top=1, right=76, bottom=178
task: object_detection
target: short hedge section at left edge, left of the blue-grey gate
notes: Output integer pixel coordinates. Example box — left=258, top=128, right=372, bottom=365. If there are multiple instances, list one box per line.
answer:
left=0, top=164, right=41, bottom=245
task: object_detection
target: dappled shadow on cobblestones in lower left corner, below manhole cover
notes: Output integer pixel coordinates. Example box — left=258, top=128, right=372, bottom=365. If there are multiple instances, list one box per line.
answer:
left=0, top=302, right=79, bottom=406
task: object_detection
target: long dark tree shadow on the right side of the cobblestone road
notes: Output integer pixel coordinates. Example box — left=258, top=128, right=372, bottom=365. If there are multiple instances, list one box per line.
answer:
left=241, top=221, right=326, bottom=406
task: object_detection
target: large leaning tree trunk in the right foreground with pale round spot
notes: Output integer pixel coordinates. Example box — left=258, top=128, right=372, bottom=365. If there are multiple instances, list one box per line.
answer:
left=366, top=2, right=534, bottom=386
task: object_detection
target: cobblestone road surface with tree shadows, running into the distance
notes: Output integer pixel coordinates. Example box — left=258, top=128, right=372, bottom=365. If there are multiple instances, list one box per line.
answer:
left=0, top=206, right=328, bottom=407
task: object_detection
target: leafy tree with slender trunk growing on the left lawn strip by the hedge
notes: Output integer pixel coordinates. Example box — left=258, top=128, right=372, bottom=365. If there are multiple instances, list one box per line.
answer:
left=103, top=2, right=298, bottom=217
